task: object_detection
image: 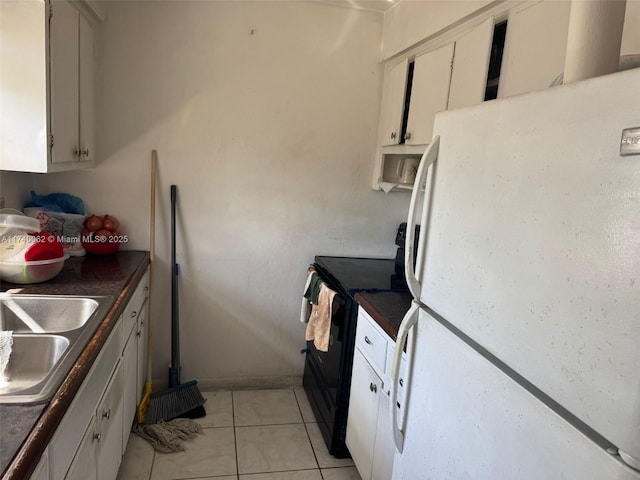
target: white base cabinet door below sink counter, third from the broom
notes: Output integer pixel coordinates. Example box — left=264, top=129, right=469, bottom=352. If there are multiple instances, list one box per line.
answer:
left=96, top=362, right=123, bottom=480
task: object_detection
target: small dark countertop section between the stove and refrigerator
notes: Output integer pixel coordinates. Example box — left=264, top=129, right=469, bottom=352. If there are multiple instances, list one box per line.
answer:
left=356, top=291, right=413, bottom=340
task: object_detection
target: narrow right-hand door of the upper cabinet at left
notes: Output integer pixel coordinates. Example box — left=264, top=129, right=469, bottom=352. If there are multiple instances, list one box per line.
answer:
left=79, top=15, right=95, bottom=161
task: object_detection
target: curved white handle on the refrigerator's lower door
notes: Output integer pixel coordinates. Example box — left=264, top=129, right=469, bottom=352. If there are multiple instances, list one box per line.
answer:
left=389, top=300, right=420, bottom=453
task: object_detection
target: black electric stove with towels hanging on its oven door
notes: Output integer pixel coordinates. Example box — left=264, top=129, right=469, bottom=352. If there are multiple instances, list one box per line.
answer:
left=303, top=256, right=408, bottom=458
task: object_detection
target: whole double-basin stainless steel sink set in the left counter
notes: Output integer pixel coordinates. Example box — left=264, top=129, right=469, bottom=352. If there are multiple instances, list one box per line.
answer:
left=0, top=294, right=113, bottom=403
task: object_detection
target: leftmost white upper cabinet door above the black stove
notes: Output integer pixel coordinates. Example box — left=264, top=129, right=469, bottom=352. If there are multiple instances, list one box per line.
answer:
left=380, top=60, right=409, bottom=145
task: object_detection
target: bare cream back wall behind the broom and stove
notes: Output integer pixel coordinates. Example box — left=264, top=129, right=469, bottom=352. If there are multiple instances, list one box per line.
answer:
left=36, top=1, right=408, bottom=385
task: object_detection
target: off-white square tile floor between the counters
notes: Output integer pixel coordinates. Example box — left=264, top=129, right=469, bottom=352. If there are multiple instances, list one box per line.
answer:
left=118, top=388, right=360, bottom=480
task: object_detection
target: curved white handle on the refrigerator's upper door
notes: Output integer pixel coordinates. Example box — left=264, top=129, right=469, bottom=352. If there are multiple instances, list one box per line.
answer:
left=404, top=135, right=440, bottom=299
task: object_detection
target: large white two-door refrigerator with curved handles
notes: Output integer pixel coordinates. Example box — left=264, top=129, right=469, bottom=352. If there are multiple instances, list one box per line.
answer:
left=390, top=69, right=640, bottom=480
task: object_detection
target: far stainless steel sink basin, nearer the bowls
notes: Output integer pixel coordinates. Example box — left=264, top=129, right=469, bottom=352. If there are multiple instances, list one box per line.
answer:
left=0, top=295, right=99, bottom=333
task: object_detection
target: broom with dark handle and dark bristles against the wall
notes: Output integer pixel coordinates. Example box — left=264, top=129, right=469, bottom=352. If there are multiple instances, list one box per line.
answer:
left=144, top=185, right=206, bottom=425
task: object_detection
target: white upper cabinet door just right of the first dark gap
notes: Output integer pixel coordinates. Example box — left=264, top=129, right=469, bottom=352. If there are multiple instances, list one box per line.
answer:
left=405, top=43, right=453, bottom=145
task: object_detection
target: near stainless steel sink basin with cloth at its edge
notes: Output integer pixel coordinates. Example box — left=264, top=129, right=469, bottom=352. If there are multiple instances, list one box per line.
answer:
left=0, top=334, right=70, bottom=395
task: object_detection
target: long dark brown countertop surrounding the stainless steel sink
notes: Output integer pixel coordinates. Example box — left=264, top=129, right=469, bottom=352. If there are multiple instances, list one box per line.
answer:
left=0, top=251, right=149, bottom=480
